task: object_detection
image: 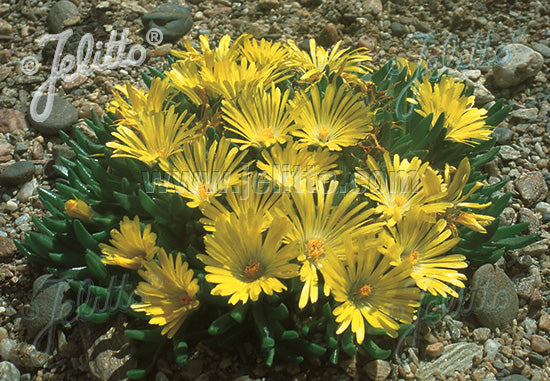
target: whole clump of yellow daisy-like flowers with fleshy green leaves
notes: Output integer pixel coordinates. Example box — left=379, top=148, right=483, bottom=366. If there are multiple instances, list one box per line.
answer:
left=24, top=35, right=536, bottom=372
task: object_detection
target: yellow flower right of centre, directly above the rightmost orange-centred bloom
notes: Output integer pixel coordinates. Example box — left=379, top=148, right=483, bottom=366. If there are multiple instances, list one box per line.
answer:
left=355, top=153, right=451, bottom=225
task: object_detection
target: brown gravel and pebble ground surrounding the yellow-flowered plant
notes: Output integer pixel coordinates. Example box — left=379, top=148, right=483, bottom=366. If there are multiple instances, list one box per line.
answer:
left=0, top=0, right=550, bottom=381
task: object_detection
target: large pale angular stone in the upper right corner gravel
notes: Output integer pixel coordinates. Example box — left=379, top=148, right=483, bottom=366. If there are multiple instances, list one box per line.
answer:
left=493, top=44, right=544, bottom=88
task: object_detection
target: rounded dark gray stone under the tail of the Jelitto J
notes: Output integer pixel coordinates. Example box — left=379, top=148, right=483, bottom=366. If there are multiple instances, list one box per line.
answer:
left=29, top=95, right=78, bottom=135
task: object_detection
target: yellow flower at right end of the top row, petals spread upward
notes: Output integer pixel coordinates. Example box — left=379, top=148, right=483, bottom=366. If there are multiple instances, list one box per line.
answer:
left=287, top=39, right=371, bottom=82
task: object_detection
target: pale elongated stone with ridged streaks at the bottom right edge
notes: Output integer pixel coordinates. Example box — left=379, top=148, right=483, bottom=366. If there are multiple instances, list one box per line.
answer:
left=415, top=343, right=483, bottom=380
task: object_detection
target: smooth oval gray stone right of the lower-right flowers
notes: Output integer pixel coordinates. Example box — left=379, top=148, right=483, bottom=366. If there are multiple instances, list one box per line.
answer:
left=471, top=264, right=519, bottom=329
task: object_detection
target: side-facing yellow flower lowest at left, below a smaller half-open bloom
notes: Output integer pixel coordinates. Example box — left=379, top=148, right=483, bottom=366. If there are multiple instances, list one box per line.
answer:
left=131, top=249, right=199, bottom=339
